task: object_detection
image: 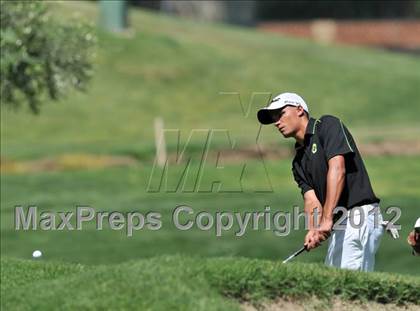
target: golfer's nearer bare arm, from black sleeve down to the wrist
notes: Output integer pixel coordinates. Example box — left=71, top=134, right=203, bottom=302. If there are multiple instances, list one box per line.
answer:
left=321, top=155, right=346, bottom=223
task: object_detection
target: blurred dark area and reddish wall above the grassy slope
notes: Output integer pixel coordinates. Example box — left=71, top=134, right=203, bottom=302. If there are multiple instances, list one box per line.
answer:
left=144, top=0, right=420, bottom=53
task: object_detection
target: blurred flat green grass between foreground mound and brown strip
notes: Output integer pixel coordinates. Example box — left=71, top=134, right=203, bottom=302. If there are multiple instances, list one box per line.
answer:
left=1, top=157, right=420, bottom=275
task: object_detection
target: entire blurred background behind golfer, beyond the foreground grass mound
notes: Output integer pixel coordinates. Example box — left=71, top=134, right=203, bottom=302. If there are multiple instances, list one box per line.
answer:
left=1, top=0, right=420, bottom=280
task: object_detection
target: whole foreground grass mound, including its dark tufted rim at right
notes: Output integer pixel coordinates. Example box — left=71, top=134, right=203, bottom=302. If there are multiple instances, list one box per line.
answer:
left=1, top=256, right=420, bottom=310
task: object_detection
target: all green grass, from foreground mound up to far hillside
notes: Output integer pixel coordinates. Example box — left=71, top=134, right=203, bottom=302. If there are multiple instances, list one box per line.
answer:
left=1, top=1, right=420, bottom=310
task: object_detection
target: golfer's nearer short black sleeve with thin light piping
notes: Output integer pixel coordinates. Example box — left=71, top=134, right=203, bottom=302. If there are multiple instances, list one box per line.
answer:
left=319, top=116, right=355, bottom=160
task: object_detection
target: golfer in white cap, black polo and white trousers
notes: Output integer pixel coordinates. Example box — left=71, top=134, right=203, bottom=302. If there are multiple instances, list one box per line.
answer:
left=257, top=93, right=384, bottom=271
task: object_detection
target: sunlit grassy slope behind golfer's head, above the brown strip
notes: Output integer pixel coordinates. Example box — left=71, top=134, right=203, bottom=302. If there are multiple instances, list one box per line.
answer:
left=1, top=1, right=420, bottom=158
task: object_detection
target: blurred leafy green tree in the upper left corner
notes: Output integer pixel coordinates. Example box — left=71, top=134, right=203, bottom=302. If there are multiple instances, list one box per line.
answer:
left=0, top=0, right=96, bottom=113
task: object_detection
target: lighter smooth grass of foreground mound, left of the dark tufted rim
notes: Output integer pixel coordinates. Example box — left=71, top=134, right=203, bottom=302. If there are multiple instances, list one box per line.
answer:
left=1, top=257, right=238, bottom=310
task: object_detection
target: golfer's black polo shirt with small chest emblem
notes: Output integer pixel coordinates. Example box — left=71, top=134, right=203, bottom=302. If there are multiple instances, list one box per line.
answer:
left=292, top=115, right=379, bottom=209
